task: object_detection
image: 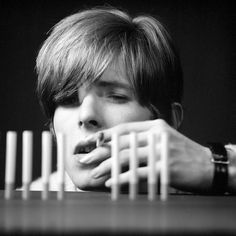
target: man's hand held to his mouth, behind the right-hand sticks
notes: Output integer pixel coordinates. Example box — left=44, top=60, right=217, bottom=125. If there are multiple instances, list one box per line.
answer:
left=79, top=119, right=213, bottom=192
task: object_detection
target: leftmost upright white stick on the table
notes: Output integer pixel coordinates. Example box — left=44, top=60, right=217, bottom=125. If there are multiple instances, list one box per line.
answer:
left=5, top=131, right=17, bottom=199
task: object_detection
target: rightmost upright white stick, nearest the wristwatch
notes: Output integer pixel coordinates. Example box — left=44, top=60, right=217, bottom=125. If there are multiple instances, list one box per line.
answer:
left=160, top=132, right=169, bottom=201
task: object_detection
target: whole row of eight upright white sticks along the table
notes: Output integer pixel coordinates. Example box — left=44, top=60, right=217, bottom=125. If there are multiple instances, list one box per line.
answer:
left=5, top=131, right=169, bottom=201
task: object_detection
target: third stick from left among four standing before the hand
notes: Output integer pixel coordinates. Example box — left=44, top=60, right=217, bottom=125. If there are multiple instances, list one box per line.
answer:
left=148, top=132, right=157, bottom=201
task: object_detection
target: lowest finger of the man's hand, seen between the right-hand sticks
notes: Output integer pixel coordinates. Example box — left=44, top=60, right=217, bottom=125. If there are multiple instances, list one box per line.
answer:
left=105, top=162, right=161, bottom=188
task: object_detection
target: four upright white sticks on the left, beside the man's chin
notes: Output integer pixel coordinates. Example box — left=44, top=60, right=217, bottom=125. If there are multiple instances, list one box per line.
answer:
left=5, top=130, right=66, bottom=200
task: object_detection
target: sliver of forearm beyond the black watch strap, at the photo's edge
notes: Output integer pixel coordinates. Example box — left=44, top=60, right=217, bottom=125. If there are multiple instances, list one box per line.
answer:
left=225, top=144, right=236, bottom=193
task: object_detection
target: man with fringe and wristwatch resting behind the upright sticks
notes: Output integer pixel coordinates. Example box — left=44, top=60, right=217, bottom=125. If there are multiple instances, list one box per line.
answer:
left=33, top=8, right=236, bottom=193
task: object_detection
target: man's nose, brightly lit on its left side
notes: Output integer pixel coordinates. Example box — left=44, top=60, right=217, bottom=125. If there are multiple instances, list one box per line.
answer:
left=78, top=94, right=102, bottom=131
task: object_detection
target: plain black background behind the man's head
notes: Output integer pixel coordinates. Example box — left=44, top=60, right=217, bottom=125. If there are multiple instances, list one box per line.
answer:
left=0, top=0, right=236, bottom=188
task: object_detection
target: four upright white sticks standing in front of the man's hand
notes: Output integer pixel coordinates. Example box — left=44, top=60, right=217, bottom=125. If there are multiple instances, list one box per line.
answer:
left=111, top=132, right=169, bottom=201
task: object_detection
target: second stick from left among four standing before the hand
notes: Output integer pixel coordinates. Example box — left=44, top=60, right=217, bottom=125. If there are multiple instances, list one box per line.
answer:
left=129, top=132, right=138, bottom=200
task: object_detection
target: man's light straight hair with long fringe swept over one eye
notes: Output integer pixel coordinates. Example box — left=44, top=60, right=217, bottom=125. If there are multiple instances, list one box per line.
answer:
left=36, top=8, right=183, bottom=121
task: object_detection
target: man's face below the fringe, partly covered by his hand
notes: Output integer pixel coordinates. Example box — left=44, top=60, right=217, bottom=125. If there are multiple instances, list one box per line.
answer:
left=53, top=62, right=151, bottom=189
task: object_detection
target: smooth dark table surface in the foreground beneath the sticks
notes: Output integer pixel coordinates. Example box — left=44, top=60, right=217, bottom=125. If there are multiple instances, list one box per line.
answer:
left=0, top=191, right=236, bottom=235
